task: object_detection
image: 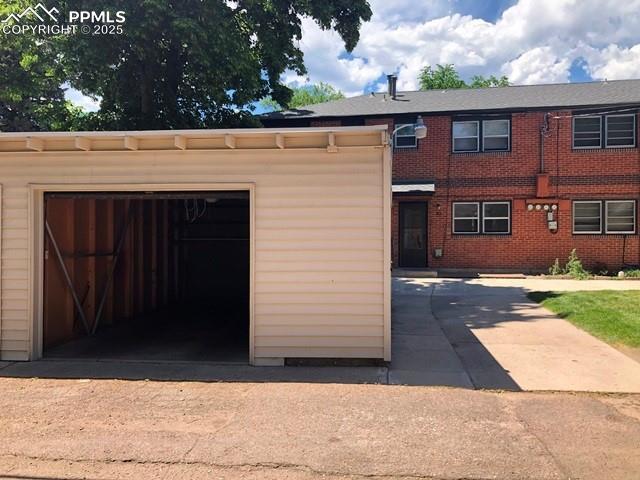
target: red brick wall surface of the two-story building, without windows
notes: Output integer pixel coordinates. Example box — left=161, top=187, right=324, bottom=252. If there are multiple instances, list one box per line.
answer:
left=366, top=112, right=640, bottom=271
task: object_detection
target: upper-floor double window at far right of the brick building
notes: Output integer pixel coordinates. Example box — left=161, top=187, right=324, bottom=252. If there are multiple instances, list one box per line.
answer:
left=573, top=114, right=636, bottom=149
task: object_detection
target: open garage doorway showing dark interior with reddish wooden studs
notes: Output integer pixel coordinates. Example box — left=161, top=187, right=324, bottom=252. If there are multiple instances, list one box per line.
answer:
left=43, top=191, right=250, bottom=363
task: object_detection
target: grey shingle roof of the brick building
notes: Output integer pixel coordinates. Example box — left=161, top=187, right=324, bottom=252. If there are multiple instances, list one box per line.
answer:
left=262, top=79, right=640, bottom=119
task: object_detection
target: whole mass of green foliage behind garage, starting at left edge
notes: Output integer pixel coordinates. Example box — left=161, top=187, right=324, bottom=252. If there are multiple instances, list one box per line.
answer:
left=0, top=0, right=371, bottom=130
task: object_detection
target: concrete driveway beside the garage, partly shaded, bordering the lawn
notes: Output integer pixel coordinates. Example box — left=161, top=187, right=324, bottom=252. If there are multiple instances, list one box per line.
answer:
left=389, top=278, right=640, bottom=392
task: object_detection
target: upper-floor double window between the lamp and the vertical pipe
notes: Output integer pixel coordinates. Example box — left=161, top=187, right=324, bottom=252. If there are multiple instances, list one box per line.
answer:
left=452, top=118, right=511, bottom=152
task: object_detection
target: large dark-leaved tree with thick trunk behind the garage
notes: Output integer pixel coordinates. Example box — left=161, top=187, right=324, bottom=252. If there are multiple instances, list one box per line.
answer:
left=61, top=0, right=371, bottom=129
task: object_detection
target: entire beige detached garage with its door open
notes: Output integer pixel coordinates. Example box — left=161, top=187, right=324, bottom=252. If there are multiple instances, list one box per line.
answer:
left=0, top=126, right=391, bottom=365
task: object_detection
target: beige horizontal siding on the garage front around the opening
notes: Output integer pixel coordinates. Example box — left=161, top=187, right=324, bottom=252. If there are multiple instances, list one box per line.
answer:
left=0, top=133, right=385, bottom=360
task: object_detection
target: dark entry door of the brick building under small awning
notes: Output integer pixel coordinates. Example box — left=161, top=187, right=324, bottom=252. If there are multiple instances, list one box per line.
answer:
left=400, top=202, right=427, bottom=268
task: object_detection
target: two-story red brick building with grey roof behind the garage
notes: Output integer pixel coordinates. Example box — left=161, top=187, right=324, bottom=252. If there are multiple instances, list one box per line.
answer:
left=262, top=76, right=640, bottom=271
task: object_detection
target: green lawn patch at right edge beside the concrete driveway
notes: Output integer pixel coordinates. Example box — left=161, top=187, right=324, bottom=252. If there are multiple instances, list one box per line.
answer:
left=529, top=290, right=640, bottom=348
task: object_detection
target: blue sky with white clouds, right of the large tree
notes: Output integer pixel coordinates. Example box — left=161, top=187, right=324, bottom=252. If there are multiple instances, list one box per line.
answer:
left=285, top=0, right=640, bottom=95
